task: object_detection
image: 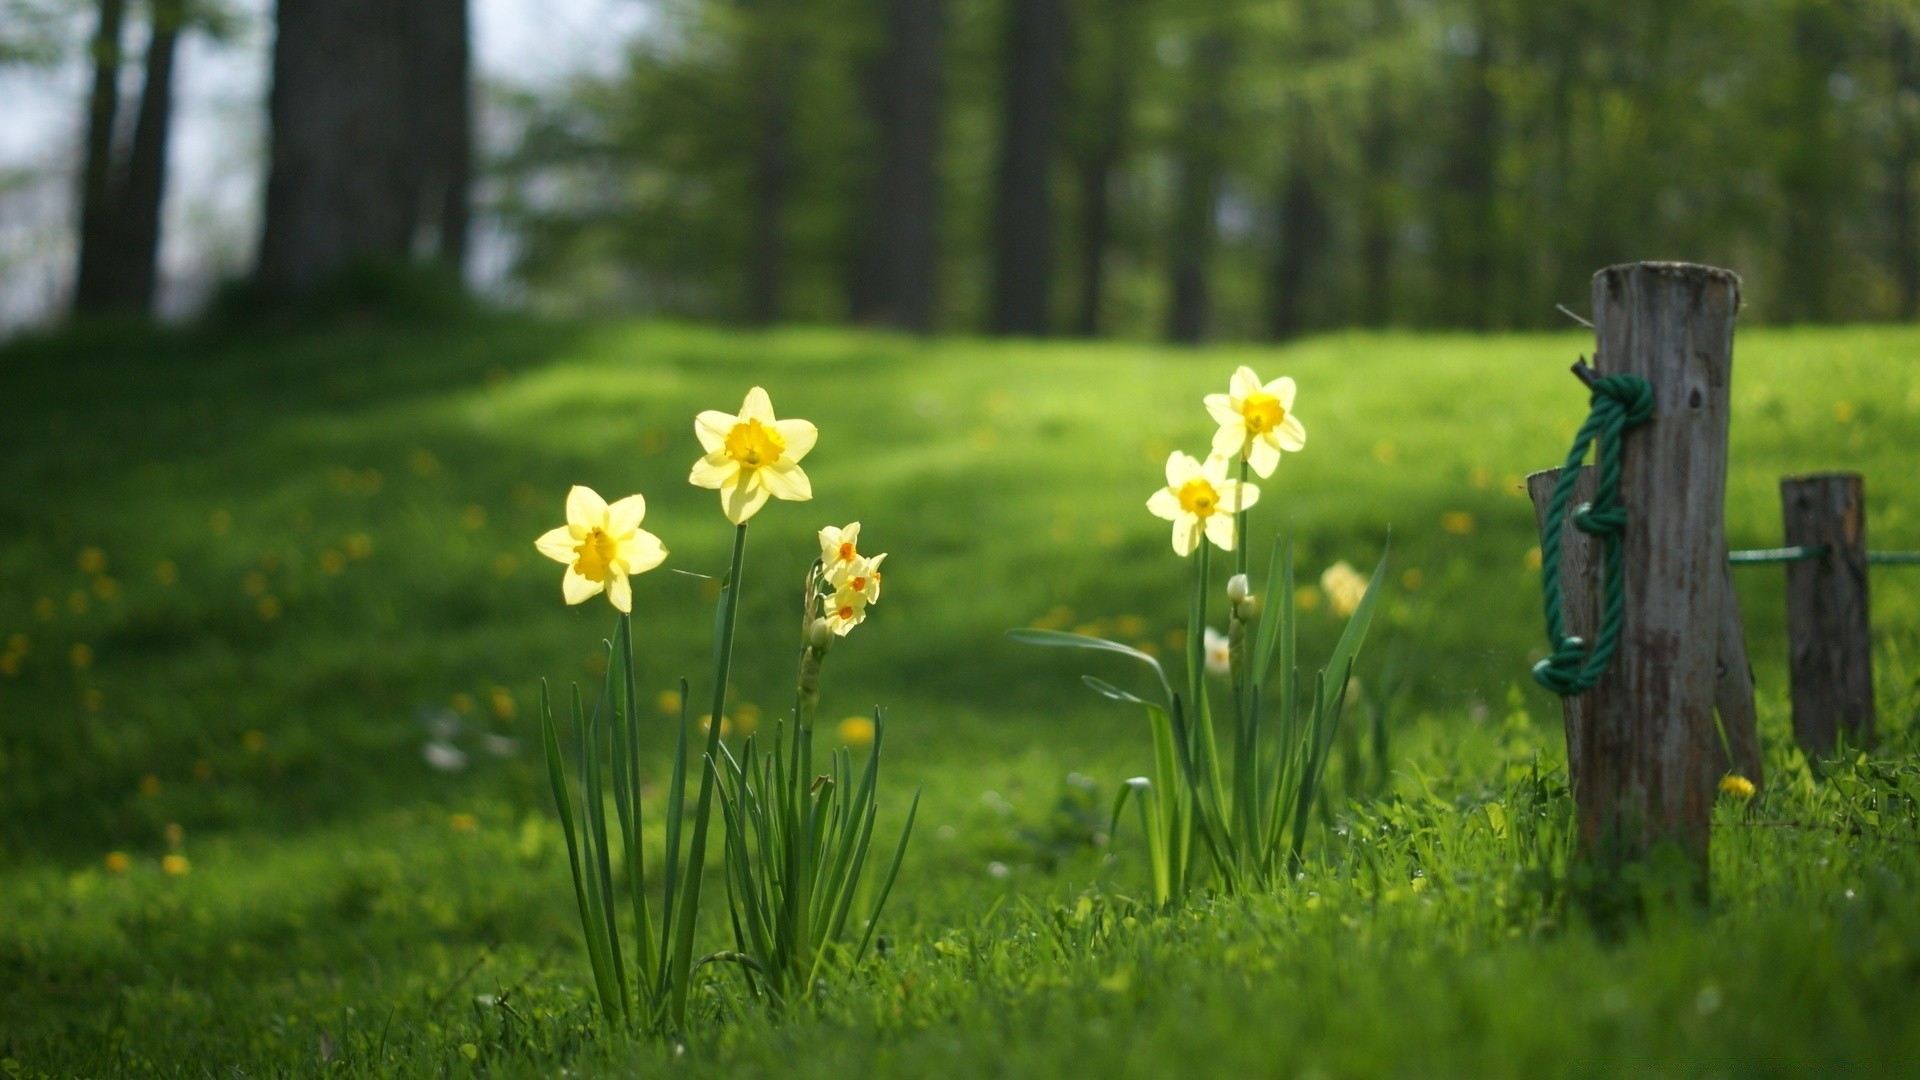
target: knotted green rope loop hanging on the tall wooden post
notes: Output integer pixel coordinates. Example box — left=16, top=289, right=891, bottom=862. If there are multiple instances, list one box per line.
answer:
left=1534, top=375, right=1653, bottom=698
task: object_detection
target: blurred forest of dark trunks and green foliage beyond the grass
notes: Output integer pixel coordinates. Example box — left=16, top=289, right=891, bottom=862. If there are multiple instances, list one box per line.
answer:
left=0, top=0, right=1920, bottom=342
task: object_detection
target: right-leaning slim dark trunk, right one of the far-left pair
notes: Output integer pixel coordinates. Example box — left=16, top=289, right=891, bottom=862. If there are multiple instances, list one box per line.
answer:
left=111, top=0, right=186, bottom=313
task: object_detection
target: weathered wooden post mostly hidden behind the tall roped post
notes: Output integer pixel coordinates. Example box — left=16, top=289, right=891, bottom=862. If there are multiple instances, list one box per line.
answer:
left=1526, top=469, right=1764, bottom=799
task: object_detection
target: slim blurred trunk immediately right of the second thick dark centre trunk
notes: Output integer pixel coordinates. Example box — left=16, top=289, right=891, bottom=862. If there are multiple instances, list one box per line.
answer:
left=1073, top=0, right=1140, bottom=338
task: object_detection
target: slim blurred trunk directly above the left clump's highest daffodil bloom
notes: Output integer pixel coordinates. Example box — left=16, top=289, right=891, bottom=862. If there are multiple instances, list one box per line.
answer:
left=741, top=0, right=801, bottom=327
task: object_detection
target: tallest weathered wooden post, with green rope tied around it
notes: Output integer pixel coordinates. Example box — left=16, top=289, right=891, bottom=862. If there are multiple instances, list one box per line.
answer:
left=1574, top=263, right=1740, bottom=897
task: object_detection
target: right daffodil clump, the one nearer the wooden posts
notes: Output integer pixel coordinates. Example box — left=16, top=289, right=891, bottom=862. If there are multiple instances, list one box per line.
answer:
left=1010, top=367, right=1386, bottom=905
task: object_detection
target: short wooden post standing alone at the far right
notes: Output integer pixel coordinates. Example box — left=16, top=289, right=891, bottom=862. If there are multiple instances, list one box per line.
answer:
left=1780, top=473, right=1874, bottom=753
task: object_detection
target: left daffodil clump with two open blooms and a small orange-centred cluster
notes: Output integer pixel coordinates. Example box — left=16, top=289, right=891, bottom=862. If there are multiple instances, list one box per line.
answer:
left=534, top=386, right=918, bottom=1032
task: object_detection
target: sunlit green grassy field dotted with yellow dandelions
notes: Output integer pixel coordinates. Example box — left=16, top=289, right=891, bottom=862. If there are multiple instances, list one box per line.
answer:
left=0, top=317, right=1920, bottom=1076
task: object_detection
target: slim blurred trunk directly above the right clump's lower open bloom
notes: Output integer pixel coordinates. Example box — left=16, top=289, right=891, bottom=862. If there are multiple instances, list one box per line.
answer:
left=1167, top=25, right=1233, bottom=344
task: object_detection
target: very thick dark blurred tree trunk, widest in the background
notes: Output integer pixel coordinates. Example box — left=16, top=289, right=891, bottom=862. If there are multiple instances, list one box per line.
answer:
left=255, top=0, right=472, bottom=294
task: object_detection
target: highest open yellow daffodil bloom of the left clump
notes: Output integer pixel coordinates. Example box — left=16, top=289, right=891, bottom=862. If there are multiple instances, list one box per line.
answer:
left=687, top=386, right=820, bottom=525
